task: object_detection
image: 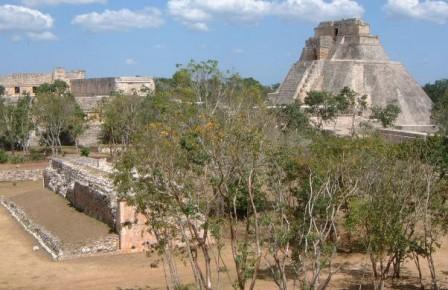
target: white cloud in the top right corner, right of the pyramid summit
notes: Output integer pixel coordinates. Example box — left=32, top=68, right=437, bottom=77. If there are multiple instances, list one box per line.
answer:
left=385, top=0, right=448, bottom=24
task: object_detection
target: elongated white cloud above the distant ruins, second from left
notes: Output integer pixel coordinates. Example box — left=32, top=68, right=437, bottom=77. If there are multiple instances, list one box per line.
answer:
left=72, top=7, right=164, bottom=31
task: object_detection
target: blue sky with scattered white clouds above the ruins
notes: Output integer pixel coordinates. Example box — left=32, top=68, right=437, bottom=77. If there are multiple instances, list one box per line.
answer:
left=0, top=0, right=448, bottom=84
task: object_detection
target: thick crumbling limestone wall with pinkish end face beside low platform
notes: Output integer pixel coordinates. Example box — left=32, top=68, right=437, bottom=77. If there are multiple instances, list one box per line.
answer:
left=44, top=157, right=155, bottom=252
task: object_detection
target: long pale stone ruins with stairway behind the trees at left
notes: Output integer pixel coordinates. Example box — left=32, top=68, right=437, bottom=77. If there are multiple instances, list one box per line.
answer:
left=0, top=68, right=155, bottom=146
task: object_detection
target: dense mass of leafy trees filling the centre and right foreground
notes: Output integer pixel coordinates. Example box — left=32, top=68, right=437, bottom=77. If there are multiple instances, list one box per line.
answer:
left=108, top=62, right=448, bottom=290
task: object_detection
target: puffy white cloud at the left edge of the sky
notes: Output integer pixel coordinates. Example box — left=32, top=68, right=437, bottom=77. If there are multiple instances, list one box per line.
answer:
left=0, top=5, right=56, bottom=41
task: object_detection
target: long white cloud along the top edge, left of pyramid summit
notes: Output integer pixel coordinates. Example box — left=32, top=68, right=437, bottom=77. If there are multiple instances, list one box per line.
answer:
left=168, top=0, right=364, bottom=30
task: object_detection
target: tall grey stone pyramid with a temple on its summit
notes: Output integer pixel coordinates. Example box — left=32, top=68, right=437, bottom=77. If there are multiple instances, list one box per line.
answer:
left=270, top=19, right=432, bottom=128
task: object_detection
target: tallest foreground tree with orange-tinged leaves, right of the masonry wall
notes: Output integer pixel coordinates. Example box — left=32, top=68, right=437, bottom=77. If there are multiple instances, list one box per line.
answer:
left=115, top=62, right=274, bottom=289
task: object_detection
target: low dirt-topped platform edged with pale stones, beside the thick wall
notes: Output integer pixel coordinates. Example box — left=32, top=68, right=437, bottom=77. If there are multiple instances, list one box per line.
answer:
left=0, top=181, right=119, bottom=260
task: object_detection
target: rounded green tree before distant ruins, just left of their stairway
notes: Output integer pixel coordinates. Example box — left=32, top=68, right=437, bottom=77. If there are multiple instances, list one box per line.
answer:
left=32, top=80, right=86, bottom=154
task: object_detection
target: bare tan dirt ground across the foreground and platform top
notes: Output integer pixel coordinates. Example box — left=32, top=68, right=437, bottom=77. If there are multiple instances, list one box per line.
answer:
left=0, top=182, right=448, bottom=290
